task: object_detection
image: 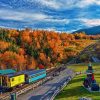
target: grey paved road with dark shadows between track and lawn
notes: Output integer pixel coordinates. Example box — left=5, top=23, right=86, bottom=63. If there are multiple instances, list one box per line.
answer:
left=17, top=69, right=73, bottom=100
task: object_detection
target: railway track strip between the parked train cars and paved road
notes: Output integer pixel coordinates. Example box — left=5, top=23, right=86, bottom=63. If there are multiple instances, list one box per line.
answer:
left=0, top=67, right=62, bottom=100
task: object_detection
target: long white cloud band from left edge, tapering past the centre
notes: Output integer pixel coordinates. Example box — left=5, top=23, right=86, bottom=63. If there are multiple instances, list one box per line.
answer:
left=0, top=9, right=69, bottom=24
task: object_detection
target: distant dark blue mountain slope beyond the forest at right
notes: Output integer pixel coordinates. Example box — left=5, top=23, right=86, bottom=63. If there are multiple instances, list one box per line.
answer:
left=73, top=26, right=100, bottom=35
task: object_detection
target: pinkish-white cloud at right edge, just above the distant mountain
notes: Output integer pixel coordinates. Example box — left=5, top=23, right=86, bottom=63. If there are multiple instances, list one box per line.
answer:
left=80, top=19, right=100, bottom=26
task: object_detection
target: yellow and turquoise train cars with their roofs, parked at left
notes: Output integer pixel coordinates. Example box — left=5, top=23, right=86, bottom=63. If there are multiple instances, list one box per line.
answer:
left=0, top=69, right=47, bottom=89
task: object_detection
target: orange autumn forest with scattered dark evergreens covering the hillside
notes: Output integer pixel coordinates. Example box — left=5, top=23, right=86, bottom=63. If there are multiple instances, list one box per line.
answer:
left=0, top=28, right=100, bottom=71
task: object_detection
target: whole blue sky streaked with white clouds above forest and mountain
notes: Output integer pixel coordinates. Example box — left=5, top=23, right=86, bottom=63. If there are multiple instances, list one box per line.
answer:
left=0, top=0, right=100, bottom=32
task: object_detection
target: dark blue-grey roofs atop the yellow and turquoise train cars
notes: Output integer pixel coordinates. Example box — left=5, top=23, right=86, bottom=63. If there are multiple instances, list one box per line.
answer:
left=6, top=69, right=46, bottom=78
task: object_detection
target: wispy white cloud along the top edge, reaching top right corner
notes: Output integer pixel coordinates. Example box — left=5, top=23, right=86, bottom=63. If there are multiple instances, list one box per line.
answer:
left=36, top=0, right=100, bottom=9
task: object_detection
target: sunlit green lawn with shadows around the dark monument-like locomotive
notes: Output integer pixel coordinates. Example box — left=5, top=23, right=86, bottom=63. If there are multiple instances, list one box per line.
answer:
left=55, top=63, right=100, bottom=100
